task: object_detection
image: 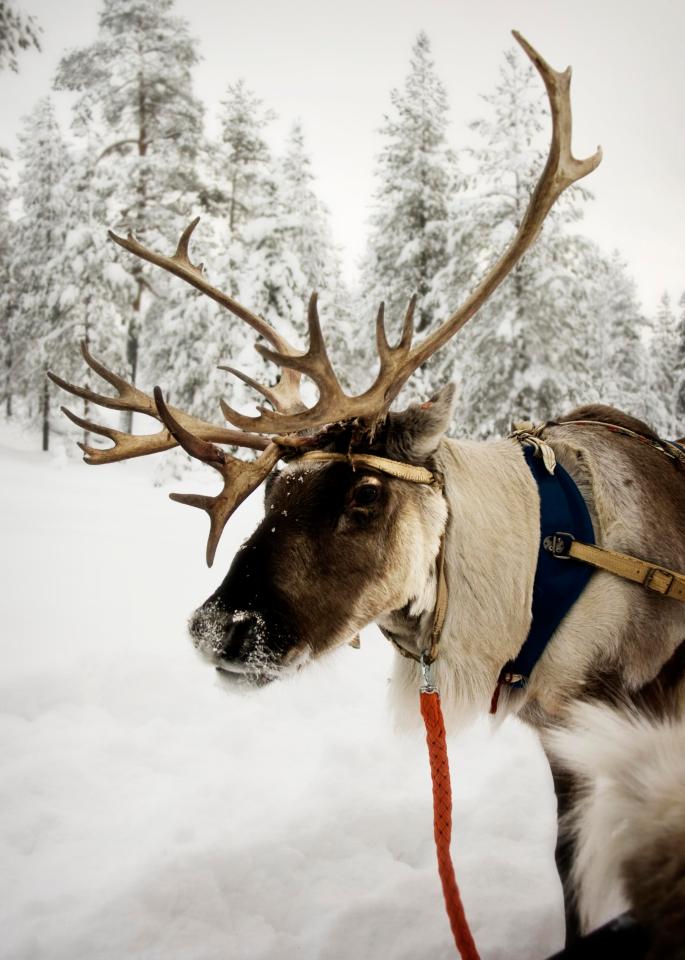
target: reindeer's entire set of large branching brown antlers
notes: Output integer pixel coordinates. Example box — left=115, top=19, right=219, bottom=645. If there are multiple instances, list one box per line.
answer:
left=49, top=31, right=602, bottom=566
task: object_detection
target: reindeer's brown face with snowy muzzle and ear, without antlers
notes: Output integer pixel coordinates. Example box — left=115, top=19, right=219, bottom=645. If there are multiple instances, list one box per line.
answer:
left=190, top=385, right=454, bottom=681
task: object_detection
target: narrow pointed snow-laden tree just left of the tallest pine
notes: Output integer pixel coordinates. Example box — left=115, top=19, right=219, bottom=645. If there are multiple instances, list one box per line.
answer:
left=9, top=97, right=78, bottom=450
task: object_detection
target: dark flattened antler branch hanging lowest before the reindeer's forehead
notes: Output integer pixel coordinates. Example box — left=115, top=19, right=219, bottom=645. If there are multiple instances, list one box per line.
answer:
left=154, top=387, right=281, bottom=567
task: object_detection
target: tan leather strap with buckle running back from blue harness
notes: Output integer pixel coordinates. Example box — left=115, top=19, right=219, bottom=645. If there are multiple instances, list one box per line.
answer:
left=544, top=533, right=685, bottom=603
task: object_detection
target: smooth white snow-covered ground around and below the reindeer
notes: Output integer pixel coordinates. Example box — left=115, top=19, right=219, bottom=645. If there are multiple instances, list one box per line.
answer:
left=0, top=428, right=562, bottom=960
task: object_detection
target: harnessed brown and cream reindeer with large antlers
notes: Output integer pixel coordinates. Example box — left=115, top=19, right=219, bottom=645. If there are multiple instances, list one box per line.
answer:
left=51, top=33, right=685, bottom=957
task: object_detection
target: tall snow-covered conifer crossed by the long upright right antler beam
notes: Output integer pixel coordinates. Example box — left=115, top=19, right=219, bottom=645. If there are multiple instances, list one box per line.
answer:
left=438, top=50, right=597, bottom=436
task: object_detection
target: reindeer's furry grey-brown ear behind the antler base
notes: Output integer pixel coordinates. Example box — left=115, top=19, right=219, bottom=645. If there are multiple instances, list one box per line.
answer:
left=386, top=383, right=456, bottom=462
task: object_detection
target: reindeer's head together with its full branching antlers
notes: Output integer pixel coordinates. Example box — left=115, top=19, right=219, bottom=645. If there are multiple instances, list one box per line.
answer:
left=50, top=33, right=601, bottom=681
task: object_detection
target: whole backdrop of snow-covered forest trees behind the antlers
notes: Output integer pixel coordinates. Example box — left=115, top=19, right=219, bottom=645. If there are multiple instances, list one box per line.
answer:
left=0, top=0, right=685, bottom=449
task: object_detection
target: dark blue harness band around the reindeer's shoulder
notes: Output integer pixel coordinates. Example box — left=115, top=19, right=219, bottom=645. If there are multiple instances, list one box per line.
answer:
left=492, top=447, right=595, bottom=692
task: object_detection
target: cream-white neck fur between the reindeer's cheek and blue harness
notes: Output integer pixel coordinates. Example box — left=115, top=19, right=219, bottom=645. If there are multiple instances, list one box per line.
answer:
left=384, top=440, right=540, bottom=724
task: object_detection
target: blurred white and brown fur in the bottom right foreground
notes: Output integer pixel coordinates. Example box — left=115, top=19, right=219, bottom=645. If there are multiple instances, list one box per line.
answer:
left=546, top=704, right=685, bottom=960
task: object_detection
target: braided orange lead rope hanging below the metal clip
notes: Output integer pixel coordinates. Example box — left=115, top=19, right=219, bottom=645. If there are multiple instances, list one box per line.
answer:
left=419, top=690, right=480, bottom=960
